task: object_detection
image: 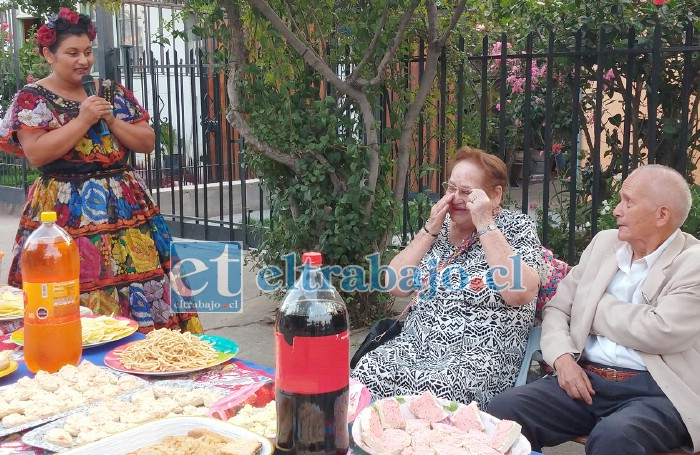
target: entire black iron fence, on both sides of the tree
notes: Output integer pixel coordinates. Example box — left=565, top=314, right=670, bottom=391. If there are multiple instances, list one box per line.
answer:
left=0, top=16, right=700, bottom=260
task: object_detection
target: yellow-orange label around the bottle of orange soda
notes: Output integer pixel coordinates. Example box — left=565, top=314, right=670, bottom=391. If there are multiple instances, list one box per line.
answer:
left=22, top=280, right=80, bottom=324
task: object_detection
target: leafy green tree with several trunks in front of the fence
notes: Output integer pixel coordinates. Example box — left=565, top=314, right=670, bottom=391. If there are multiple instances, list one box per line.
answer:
left=168, top=0, right=476, bottom=323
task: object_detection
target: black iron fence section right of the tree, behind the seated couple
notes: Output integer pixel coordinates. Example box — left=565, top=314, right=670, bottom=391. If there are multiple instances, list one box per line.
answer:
left=402, top=24, right=700, bottom=262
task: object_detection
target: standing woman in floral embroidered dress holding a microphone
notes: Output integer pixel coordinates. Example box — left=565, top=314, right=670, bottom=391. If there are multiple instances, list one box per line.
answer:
left=0, top=8, right=202, bottom=333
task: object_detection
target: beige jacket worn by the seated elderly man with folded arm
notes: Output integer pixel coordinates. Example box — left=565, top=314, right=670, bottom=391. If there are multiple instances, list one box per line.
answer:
left=541, top=229, right=700, bottom=451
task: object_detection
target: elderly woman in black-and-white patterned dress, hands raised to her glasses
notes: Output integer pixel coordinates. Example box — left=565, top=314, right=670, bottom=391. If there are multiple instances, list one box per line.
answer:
left=352, top=147, right=542, bottom=409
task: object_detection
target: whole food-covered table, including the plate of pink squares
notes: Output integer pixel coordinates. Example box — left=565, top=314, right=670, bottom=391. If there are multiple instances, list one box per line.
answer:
left=0, top=272, right=534, bottom=455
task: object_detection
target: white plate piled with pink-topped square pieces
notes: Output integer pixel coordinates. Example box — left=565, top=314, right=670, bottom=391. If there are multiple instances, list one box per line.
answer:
left=352, top=391, right=531, bottom=455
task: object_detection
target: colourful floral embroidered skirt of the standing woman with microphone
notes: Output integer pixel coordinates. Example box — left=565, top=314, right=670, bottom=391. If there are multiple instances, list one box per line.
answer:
left=8, top=170, right=202, bottom=333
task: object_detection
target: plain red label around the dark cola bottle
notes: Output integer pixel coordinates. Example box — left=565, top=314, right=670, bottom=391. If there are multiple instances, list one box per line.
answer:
left=275, top=330, right=350, bottom=395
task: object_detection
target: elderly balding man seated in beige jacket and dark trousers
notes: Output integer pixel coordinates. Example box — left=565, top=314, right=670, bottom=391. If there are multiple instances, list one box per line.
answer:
left=488, top=165, right=700, bottom=454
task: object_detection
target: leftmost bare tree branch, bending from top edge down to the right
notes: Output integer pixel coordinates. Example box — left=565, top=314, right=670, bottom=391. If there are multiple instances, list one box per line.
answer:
left=222, top=0, right=301, bottom=175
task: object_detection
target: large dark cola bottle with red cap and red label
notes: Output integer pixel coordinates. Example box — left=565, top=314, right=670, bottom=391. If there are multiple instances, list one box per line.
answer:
left=275, top=252, right=350, bottom=455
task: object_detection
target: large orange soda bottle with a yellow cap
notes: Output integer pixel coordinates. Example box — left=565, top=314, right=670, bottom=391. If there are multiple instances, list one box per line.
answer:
left=20, top=212, right=83, bottom=373
